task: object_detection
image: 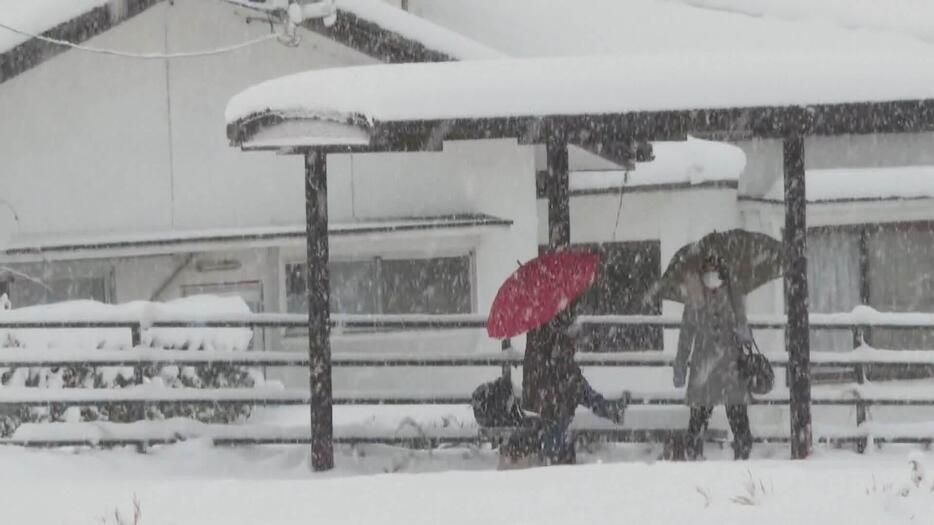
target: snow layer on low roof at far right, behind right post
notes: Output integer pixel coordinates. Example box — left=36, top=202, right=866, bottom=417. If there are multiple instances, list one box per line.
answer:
left=766, top=166, right=934, bottom=202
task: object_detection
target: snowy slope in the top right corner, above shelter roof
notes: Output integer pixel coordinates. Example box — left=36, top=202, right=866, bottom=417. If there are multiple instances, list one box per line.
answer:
left=678, top=0, right=934, bottom=44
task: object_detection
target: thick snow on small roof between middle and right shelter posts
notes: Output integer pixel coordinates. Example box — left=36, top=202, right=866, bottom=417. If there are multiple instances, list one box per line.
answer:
left=570, top=137, right=746, bottom=191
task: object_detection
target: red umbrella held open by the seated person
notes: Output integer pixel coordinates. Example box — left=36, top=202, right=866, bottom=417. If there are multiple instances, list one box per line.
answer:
left=486, top=250, right=600, bottom=339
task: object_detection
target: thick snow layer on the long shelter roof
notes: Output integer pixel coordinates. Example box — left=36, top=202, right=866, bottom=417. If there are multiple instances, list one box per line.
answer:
left=225, top=53, right=934, bottom=148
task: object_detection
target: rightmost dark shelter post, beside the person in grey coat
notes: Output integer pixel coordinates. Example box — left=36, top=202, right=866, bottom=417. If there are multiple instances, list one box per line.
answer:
left=783, top=132, right=811, bottom=459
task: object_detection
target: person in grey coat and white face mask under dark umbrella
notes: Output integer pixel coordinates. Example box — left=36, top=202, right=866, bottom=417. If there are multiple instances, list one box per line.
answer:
left=674, top=257, right=752, bottom=459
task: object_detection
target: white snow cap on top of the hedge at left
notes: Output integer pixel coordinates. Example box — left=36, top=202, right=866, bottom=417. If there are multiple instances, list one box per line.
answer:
left=0, top=295, right=253, bottom=350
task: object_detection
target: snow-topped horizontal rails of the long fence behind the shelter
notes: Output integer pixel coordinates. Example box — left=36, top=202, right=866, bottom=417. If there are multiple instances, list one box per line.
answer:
left=0, top=308, right=934, bottom=447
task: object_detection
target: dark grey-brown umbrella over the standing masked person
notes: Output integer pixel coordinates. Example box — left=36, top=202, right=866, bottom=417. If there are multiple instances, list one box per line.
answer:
left=647, top=229, right=783, bottom=302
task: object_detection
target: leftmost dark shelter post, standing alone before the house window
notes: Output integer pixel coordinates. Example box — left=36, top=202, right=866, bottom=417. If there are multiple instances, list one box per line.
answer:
left=305, top=150, right=334, bottom=471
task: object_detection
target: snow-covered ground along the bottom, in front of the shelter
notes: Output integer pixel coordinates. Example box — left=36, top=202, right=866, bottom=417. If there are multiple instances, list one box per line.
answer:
left=0, top=442, right=934, bottom=525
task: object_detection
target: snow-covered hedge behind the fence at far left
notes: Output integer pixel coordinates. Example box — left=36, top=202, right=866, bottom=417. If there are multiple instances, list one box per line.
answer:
left=0, top=296, right=262, bottom=436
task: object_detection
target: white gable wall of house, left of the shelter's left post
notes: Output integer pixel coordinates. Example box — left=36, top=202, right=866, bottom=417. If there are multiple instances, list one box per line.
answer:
left=0, top=0, right=371, bottom=234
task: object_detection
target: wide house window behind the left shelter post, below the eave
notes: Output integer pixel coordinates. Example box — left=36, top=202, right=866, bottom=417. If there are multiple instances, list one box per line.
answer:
left=285, top=254, right=474, bottom=314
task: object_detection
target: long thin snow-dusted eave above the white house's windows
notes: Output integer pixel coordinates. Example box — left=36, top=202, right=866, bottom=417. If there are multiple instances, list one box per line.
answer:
left=0, top=214, right=512, bottom=263
